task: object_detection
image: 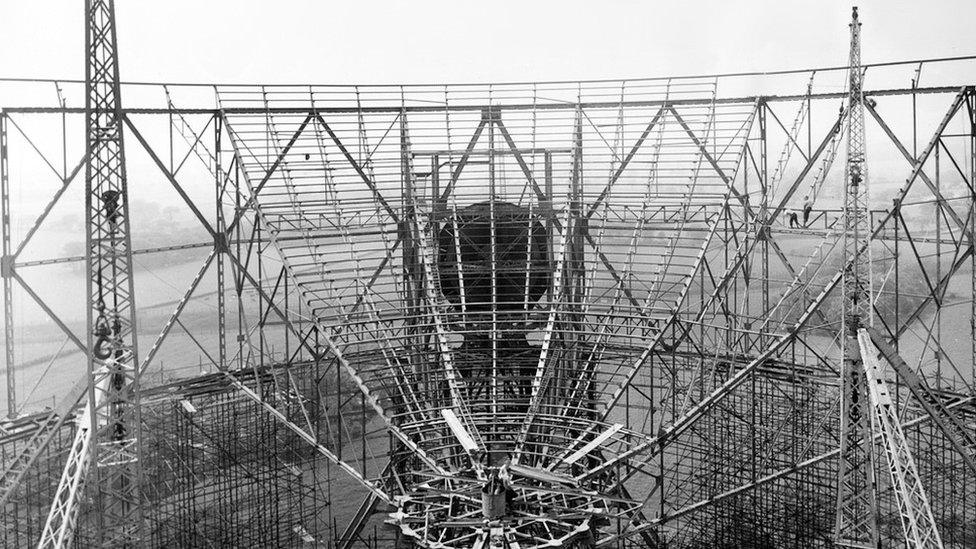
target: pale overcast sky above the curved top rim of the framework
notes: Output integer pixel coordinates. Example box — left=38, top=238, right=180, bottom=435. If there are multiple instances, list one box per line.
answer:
left=0, top=0, right=976, bottom=83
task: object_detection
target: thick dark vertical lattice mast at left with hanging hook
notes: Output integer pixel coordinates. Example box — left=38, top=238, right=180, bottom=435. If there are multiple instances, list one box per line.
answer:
left=85, top=0, right=141, bottom=547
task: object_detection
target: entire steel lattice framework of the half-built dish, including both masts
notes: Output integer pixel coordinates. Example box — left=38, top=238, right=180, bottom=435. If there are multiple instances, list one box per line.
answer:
left=0, top=2, right=976, bottom=547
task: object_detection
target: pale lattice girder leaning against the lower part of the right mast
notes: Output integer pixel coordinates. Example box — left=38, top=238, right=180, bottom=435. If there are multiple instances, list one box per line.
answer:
left=857, top=329, right=942, bottom=549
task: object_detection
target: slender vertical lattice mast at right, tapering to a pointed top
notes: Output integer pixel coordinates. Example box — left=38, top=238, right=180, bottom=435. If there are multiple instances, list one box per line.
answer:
left=834, top=7, right=878, bottom=548
